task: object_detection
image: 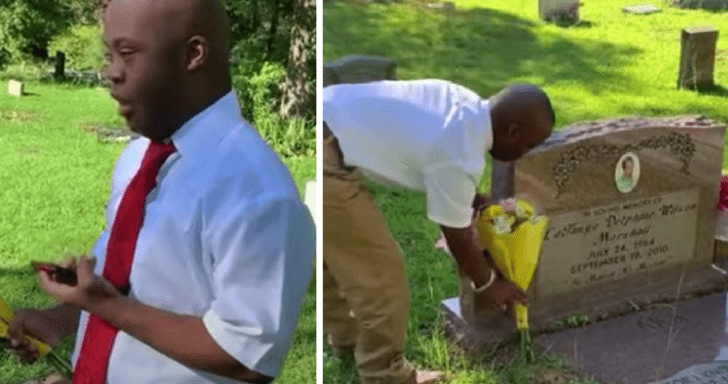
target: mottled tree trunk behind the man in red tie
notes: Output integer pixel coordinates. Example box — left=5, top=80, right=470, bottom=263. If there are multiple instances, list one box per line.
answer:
left=280, top=0, right=316, bottom=117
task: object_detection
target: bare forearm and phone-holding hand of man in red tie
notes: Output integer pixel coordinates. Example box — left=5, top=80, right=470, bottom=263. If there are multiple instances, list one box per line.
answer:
left=40, top=257, right=273, bottom=383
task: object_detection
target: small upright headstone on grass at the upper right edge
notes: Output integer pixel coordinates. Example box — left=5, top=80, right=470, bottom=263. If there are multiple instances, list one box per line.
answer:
left=677, top=27, right=718, bottom=89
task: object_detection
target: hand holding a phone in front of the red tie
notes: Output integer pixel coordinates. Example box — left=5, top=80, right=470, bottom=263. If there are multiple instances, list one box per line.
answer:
left=38, top=256, right=123, bottom=312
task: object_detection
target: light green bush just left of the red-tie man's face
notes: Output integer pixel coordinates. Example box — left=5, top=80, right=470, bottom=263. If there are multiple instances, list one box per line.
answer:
left=48, top=25, right=104, bottom=71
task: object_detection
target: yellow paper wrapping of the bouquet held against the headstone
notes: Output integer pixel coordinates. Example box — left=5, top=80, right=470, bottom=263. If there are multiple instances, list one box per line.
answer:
left=478, top=203, right=548, bottom=329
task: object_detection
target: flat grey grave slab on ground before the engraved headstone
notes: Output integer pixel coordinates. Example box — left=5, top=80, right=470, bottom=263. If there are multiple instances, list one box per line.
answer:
left=534, top=293, right=728, bottom=384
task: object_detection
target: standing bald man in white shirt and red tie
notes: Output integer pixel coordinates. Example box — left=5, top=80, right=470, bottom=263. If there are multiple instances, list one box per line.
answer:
left=11, top=0, right=315, bottom=384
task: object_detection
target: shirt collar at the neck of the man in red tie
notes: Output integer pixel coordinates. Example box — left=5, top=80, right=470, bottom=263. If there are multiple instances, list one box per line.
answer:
left=171, top=90, right=243, bottom=156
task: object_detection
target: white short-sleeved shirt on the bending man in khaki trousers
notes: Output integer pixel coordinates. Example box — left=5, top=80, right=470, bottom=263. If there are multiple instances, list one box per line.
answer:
left=323, top=80, right=493, bottom=228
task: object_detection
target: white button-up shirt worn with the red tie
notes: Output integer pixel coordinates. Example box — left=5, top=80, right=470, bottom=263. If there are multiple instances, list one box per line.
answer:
left=72, top=92, right=315, bottom=384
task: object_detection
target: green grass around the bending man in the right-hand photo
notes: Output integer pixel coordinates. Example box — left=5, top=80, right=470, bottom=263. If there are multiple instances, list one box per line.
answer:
left=323, top=0, right=728, bottom=384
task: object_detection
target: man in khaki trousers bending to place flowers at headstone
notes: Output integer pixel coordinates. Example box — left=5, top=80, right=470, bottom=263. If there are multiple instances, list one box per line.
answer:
left=323, top=80, right=554, bottom=384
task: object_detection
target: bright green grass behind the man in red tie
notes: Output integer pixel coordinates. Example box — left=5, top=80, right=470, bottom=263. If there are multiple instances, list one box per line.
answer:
left=0, top=82, right=316, bottom=384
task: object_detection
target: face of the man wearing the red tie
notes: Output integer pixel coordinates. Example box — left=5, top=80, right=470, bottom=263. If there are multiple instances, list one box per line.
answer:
left=104, top=0, right=184, bottom=139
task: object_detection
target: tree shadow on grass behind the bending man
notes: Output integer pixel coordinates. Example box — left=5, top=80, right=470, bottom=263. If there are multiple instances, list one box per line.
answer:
left=324, top=2, right=642, bottom=95
